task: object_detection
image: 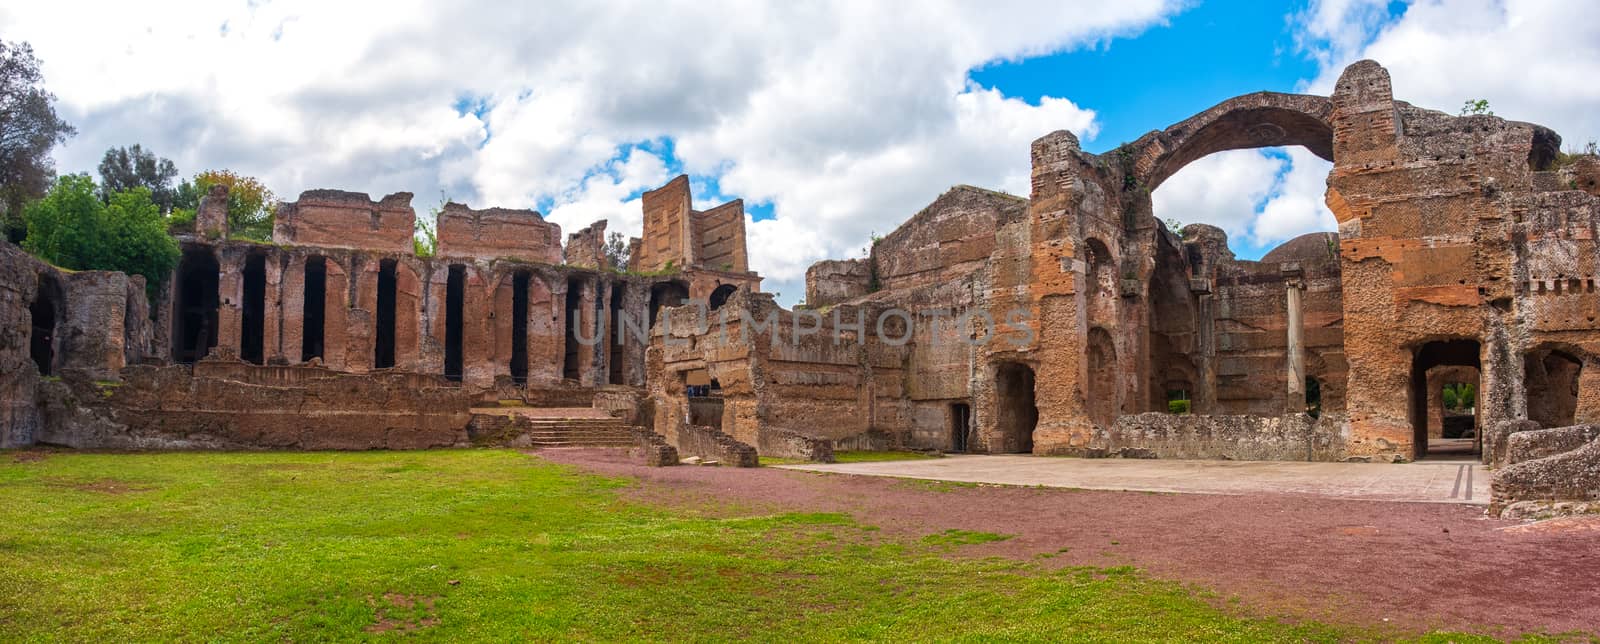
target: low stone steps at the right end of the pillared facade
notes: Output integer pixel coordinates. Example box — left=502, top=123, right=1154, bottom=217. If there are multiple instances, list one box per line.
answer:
left=467, top=407, right=638, bottom=447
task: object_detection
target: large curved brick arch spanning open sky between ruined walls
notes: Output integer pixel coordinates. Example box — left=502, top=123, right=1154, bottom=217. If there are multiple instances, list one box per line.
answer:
left=1115, top=91, right=1333, bottom=191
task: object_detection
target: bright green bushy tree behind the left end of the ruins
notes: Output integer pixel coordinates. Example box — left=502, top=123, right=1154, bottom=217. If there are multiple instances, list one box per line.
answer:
left=22, top=175, right=179, bottom=296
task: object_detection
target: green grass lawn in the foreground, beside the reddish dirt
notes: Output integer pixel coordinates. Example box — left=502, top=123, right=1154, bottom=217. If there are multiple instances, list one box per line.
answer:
left=0, top=450, right=1497, bottom=641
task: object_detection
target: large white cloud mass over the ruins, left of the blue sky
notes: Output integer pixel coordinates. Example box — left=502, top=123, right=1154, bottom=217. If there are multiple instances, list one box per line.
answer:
left=0, top=0, right=1178, bottom=301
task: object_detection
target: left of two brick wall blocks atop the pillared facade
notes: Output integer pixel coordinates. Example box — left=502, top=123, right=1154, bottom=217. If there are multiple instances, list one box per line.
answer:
left=272, top=191, right=422, bottom=253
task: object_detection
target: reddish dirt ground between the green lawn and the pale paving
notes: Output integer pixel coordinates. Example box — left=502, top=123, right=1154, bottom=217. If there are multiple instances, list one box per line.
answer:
left=538, top=450, right=1600, bottom=636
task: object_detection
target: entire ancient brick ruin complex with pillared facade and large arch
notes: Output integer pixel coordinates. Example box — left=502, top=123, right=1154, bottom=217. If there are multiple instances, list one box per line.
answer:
left=0, top=61, right=1600, bottom=508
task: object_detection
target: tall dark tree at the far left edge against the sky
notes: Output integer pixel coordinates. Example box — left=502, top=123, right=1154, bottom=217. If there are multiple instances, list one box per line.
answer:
left=0, top=40, right=77, bottom=242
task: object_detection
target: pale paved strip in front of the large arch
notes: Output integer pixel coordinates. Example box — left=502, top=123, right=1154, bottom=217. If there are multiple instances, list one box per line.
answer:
left=784, top=455, right=1490, bottom=505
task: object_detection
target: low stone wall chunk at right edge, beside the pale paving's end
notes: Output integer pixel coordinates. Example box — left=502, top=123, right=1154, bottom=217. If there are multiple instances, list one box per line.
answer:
left=1490, top=441, right=1600, bottom=514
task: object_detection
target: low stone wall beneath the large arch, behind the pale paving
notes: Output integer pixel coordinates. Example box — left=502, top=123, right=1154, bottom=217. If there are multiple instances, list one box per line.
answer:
left=1088, top=412, right=1349, bottom=461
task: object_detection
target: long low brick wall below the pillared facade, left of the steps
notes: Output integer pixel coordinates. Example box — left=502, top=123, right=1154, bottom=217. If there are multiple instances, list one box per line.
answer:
left=38, top=365, right=469, bottom=450
